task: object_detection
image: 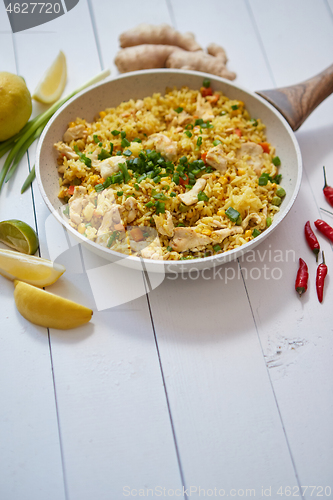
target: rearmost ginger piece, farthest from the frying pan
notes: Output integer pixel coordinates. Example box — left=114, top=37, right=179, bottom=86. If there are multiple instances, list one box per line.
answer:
left=119, top=23, right=202, bottom=51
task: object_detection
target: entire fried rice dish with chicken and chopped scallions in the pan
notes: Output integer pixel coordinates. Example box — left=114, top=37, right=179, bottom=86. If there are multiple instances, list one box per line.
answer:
left=55, top=82, right=285, bottom=260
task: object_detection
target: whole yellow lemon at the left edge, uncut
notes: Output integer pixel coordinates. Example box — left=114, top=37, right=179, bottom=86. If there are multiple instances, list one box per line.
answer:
left=0, top=71, right=32, bottom=142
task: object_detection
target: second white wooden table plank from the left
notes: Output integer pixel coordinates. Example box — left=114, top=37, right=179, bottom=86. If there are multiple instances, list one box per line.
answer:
left=12, top=0, right=181, bottom=500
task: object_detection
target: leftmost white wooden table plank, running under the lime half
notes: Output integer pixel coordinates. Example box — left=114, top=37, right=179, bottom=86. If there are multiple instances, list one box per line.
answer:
left=0, top=3, right=65, bottom=500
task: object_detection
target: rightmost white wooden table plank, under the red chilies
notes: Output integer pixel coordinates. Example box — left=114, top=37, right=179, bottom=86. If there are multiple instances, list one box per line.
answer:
left=242, top=0, right=333, bottom=492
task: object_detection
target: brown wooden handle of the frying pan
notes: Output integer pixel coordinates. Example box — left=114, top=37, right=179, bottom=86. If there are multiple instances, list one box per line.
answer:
left=256, top=64, right=333, bottom=130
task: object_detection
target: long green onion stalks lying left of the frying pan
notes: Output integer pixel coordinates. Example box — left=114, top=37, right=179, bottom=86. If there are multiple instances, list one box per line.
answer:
left=0, top=69, right=110, bottom=190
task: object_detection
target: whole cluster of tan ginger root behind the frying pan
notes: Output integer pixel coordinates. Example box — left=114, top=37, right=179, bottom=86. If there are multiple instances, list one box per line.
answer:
left=115, top=24, right=236, bottom=80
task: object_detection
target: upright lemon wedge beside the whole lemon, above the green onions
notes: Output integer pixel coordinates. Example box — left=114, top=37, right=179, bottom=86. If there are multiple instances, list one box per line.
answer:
left=32, top=51, right=67, bottom=104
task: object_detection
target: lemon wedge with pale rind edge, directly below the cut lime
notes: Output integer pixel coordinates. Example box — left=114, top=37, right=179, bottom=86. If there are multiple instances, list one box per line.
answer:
left=0, top=249, right=66, bottom=287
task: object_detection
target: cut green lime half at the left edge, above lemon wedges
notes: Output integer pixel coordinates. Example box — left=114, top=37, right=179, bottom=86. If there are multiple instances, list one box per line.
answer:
left=0, top=219, right=39, bottom=255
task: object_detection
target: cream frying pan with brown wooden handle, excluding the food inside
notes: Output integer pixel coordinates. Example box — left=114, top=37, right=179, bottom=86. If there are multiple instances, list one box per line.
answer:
left=36, top=65, right=333, bottom=273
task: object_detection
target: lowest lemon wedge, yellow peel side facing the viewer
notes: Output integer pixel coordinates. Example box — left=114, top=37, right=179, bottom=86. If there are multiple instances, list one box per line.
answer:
left=14, top=280, right=93, bottom=330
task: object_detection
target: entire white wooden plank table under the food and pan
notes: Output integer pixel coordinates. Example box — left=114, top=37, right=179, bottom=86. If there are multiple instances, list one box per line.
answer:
left=0, top=0, right=333, bottom=500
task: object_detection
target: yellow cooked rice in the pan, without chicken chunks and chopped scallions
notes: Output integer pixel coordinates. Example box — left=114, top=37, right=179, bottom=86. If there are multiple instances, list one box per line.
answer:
left=58, top=83, right=279, bottom=260
